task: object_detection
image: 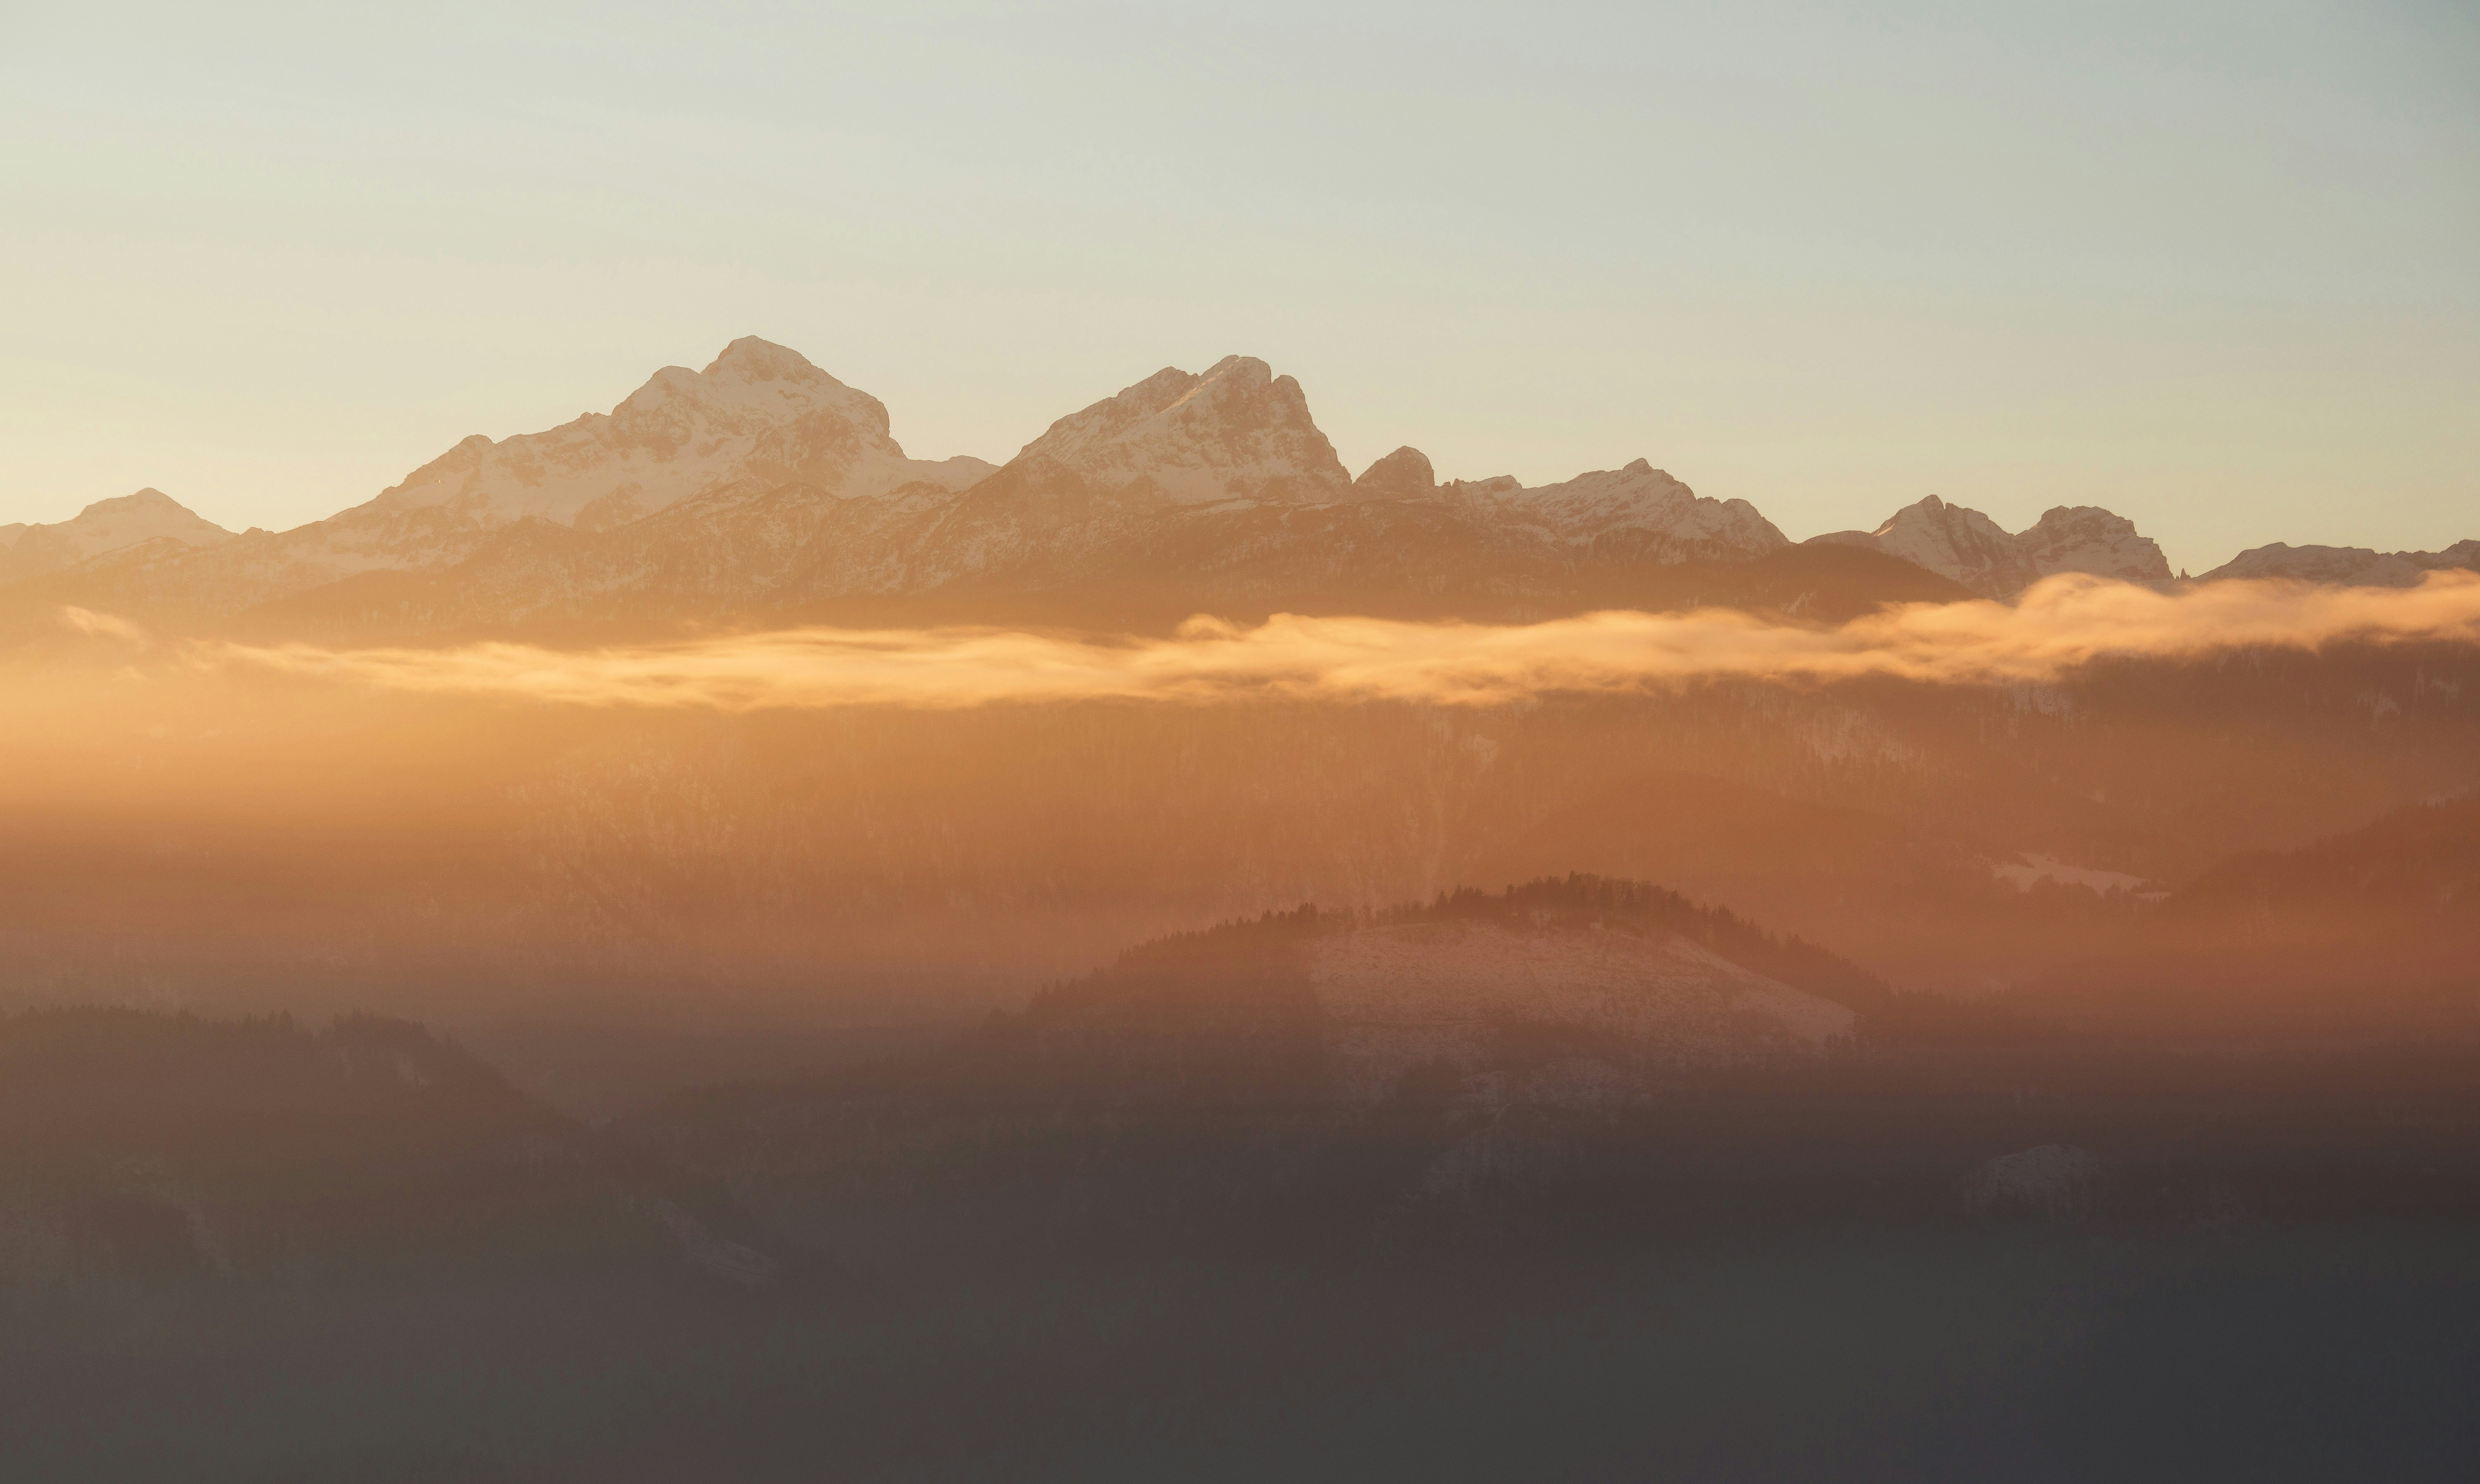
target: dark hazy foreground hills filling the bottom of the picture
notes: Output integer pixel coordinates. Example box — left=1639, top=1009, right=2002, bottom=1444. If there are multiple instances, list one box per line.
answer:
left=0, top=879, right=2480, bottom=1482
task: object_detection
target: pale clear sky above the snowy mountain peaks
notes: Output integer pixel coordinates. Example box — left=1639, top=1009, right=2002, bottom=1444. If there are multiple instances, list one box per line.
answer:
left=0, top=0, right=2480, bottom=571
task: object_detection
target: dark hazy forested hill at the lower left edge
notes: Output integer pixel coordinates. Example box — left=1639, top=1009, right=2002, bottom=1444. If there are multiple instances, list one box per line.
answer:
left=0, top=1010, right=667, bottom=1291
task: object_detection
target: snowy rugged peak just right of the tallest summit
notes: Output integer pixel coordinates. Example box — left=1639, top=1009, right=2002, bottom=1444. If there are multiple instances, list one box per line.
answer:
left=1017, top=355, right=1352, bottom=504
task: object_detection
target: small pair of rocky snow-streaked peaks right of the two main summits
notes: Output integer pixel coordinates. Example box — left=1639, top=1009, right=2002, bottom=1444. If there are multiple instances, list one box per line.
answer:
left=1810, top=494, right=2170, bottom=598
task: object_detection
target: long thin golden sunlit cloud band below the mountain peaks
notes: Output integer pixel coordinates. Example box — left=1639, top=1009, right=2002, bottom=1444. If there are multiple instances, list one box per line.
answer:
left=155, top=573, right=2480, bottom=712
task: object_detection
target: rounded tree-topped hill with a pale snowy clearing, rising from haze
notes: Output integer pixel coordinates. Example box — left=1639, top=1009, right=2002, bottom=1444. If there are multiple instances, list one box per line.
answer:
left=975, top=874, right=2019, bottom=1107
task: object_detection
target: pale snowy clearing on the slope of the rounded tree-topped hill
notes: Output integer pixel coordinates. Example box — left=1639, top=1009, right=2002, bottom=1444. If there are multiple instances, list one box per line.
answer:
left=1309, top=921, right=1855, bottom=1099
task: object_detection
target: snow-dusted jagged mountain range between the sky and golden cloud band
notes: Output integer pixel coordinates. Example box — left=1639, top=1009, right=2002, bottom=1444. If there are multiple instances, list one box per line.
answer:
left=14, top=338, right=2480, bottom=633
